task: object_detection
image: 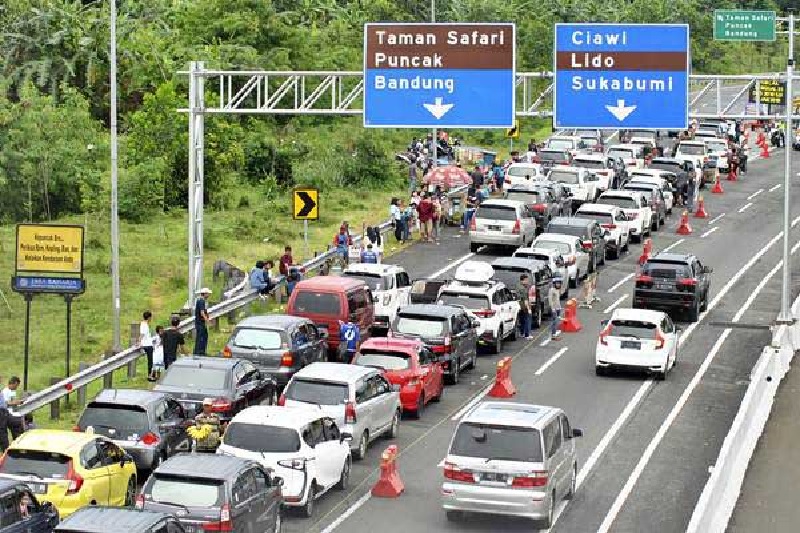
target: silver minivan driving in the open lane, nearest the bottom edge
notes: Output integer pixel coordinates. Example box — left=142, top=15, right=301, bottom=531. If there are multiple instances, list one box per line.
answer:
left=442, top=402, right=583, bottom=529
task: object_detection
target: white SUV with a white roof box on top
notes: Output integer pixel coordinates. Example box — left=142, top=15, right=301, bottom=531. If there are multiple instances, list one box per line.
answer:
left=438, top=261, right=519, bottom=353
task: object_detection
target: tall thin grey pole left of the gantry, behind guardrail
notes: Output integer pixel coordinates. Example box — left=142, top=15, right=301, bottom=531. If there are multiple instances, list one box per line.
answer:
left=111, top=0, right=122, bottom=353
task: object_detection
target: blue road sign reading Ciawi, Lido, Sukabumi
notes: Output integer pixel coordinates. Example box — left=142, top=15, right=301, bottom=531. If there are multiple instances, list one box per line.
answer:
left=553, top=24, right=690, bottom=130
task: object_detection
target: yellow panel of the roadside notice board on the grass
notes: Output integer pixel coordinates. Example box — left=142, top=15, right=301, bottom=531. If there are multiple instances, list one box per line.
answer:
left=16, top=224, right=83, bottom=274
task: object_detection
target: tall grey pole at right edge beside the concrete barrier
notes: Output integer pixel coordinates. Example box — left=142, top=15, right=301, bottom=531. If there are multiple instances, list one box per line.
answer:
left=778, top=11, right=794, bottom=324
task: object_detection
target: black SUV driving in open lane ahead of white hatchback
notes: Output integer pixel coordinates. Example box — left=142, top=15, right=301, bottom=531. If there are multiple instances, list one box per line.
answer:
left=633, top=253, right=712, bottom=322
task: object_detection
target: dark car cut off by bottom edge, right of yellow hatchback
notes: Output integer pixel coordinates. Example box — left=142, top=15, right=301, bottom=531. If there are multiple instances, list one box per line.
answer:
left=56, top=506, right=186, bottom=533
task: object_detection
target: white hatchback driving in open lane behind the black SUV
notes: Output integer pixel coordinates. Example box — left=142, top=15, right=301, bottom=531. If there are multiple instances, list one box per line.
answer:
left=595, top=308, right=680, bottom=380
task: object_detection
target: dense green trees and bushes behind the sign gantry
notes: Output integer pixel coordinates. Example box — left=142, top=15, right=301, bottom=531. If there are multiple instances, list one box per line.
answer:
left=0, top=0, right=794, bottom=222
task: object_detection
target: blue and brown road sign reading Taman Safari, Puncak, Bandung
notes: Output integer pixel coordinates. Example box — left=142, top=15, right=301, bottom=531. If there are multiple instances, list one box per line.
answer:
left=364, top=23, right=516, bottom=128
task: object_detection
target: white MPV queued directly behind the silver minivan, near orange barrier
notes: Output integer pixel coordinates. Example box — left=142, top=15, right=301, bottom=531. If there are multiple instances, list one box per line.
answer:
left=217, top=405, right=352, bottom=517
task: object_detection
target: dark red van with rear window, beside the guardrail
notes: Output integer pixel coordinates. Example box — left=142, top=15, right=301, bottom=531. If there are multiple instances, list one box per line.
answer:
left=286, top=276, right=375, bottom=361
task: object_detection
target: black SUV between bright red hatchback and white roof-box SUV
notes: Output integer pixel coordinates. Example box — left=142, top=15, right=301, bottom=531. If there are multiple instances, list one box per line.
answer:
left=392, top=304, right=480, bottom=385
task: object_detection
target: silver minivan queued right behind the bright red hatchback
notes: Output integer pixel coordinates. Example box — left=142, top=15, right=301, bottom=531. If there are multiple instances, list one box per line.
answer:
left=278, top=363, right=401, bottom=459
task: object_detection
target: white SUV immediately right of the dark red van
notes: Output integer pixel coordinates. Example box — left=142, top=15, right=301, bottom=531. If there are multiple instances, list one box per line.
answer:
left=342, top=263, right=411, bottom=330
